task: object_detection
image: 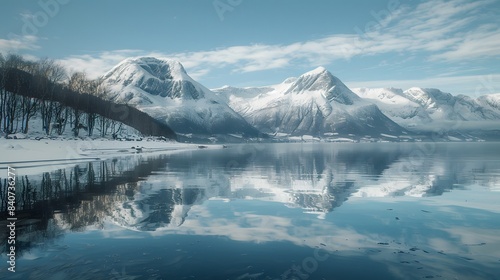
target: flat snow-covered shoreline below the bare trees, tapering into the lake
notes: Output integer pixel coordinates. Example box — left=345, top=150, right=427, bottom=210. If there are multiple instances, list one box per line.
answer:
left=0, top=138, right=222, bottom=177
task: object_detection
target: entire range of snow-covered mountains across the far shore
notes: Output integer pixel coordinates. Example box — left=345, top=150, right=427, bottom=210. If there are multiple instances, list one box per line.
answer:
left=103, top=57, right=500, bottom=140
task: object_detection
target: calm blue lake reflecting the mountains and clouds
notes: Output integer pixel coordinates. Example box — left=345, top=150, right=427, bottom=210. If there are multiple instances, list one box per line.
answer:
left=0, top=143, right=500, bottom=280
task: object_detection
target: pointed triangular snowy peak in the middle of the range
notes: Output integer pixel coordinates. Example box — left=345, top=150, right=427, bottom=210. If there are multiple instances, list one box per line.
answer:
left=213, top=67, right=405, bottom=136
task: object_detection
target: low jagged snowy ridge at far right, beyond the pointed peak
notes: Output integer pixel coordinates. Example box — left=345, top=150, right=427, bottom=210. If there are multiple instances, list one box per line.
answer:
left=353, top=87, right=500, bottom=130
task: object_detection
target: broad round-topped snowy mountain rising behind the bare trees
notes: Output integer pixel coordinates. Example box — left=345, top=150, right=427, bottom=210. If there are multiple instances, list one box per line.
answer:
left=103, top=57, right=258, bottom=135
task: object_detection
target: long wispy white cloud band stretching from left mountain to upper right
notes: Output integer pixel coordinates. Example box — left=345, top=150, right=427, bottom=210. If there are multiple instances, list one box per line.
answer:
left=52, top=0, right=500, bottom=82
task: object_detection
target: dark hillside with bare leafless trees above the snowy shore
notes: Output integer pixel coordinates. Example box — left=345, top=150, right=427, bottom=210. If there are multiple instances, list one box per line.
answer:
left=0, top=53, right=175, bottom=138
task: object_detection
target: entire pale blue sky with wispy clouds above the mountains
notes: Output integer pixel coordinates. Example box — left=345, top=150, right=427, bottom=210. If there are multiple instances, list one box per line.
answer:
left=0, top=0, right=500, bottom=96
